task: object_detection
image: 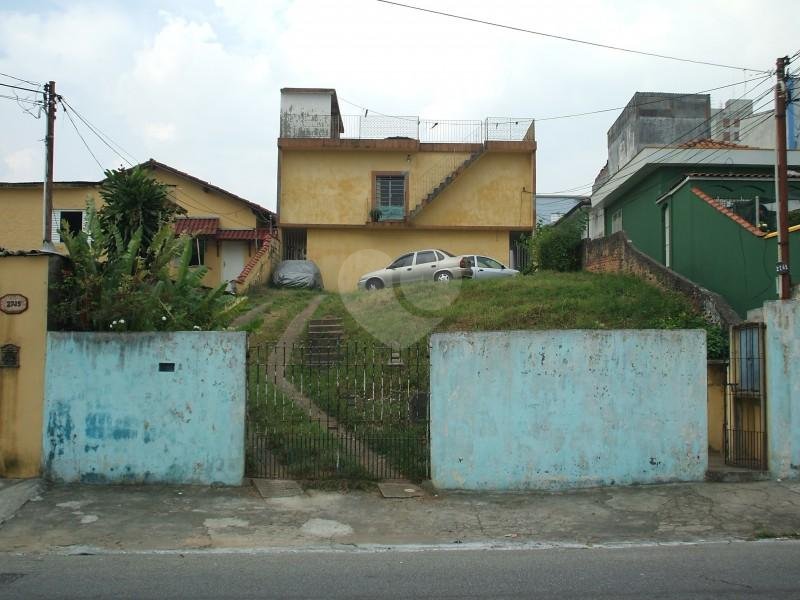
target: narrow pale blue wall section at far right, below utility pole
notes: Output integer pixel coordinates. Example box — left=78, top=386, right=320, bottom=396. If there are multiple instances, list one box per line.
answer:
left=764, top=300, right=800, bottom=479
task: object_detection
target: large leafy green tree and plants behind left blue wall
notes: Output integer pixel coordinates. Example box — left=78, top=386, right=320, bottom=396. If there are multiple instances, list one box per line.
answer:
left=52, top=169, right=244, bottom=331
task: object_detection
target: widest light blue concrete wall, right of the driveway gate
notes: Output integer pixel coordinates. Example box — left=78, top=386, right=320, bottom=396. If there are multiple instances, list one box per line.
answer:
left=430, top=330, right=708, bottom=490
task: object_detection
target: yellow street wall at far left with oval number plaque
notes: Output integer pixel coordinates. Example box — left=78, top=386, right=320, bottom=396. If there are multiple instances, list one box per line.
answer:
left=0, top=256, right=49, bottom=477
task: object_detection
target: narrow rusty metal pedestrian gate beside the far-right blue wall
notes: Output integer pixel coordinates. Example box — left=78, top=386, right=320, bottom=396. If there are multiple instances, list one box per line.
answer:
left=723, top=323, right=767, bottom=471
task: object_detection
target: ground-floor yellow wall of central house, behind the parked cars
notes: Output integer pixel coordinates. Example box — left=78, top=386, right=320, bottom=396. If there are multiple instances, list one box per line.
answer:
left=307, top=227, right=509, bottom=291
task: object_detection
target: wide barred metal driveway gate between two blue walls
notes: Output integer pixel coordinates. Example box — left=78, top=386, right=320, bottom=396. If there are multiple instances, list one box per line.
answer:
left=245, top=341, right=430, bottom=480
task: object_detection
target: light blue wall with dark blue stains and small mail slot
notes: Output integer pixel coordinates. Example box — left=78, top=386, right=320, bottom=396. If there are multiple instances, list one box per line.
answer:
left=42, top=332, right=246, bottom=485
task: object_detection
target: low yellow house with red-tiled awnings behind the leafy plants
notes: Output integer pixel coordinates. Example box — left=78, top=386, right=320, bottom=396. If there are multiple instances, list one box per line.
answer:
left=0, top=159, right=275, bottom=291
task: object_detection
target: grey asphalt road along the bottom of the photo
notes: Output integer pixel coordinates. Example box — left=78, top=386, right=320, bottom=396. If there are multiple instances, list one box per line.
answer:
left=0, top=541, right=800, bottom=600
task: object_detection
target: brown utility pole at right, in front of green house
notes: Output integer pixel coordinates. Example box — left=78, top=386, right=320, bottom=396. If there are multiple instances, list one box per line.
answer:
left=775, top=57, right=792, bottom=300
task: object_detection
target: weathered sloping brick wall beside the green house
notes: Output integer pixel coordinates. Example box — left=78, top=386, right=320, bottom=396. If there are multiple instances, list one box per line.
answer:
left=582, top=231, right=741, bottom=329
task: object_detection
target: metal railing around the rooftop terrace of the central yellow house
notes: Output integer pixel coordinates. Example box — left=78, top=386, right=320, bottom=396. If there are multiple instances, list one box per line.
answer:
left=281, top=113, right=535, bottom=144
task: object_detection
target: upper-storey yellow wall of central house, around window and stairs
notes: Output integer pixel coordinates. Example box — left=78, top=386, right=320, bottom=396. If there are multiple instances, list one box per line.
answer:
left=280, top=149, right=533, bottom=227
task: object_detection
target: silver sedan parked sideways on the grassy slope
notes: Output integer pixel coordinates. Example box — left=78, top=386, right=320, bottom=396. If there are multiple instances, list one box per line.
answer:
left=358, top=249, right=470, bottom=290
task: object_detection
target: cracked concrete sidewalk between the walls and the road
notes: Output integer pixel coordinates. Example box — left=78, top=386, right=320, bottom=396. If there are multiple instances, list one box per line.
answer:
left=0, top=481, right=800, bottom=553
